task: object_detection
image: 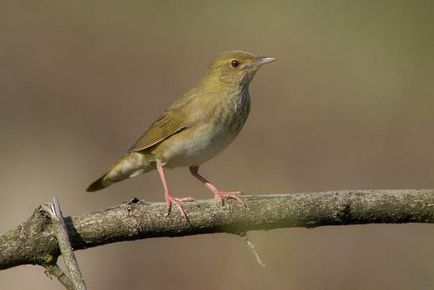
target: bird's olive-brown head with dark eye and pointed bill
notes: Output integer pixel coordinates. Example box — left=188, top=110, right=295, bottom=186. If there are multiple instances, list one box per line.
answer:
left=205, top=50, right=276, bottom=87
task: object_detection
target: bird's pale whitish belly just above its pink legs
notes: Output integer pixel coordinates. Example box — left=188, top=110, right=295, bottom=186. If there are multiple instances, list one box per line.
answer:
left=152, top=124, right=239, bottom=168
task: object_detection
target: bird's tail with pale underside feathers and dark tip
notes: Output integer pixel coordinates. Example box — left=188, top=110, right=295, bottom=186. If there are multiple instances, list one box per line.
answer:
left=86, top=152, right=156, bottom=192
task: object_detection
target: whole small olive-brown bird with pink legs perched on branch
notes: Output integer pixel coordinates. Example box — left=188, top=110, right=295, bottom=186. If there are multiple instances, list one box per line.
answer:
left=87, top=50, right=275, bottom=217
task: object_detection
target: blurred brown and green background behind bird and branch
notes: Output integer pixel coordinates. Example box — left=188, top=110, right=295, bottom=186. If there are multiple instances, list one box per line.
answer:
left=0, top=0, right=434, bottom=290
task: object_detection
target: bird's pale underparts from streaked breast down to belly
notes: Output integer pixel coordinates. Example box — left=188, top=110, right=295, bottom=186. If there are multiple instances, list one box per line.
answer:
left=152, top=89, right=250, bottom=167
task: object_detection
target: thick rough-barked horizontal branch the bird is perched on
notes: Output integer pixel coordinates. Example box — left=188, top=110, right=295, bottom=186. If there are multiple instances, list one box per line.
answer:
left=0, top=190, right=434, bottom=270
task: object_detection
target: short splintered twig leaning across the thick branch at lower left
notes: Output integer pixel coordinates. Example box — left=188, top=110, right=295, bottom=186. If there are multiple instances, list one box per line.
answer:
left=50, top=198, right=87, bottom=290
